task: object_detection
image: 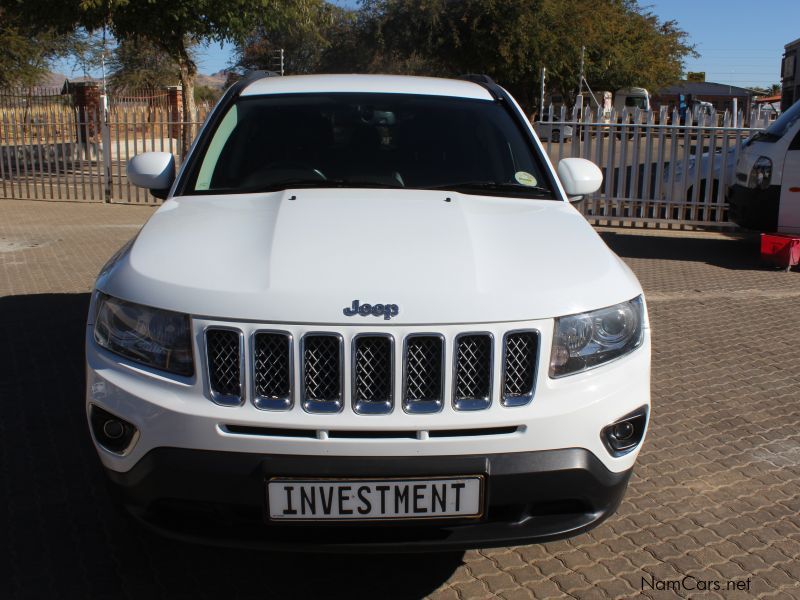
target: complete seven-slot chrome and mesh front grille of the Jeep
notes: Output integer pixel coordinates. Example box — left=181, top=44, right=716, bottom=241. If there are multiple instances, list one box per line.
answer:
left=205, top=324, right=540, bottom=415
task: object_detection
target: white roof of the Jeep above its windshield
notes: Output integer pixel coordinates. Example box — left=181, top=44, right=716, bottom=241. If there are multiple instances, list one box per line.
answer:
left=241, top=75, right=492, bottom=100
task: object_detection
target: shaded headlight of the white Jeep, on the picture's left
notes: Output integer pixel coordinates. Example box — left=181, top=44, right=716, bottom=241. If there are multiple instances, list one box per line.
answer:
left=94, top=294, right=194, bottom=376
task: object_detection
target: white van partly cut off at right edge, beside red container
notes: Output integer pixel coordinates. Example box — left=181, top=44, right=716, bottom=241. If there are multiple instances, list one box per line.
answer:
left=730, top=102, right=800, bottom=234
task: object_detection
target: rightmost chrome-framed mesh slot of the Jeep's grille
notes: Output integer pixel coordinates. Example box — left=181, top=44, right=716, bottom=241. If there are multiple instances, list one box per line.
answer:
left=501, top=330, right=539, bottom=406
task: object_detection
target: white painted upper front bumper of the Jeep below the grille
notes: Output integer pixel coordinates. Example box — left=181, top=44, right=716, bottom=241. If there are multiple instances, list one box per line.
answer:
left=86, top=324, right=650, bottom=473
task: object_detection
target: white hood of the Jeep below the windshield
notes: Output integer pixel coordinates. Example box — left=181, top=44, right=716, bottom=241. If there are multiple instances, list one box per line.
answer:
left=97, top=189, right=641, bottom=326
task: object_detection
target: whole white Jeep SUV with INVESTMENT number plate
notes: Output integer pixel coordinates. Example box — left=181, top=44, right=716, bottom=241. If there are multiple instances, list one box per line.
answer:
left=86, top=74, right=650, bottom=551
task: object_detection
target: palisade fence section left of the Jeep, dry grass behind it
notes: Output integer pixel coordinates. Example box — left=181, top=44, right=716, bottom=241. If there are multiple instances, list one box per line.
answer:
left=0, top=89, right=211, bottom=204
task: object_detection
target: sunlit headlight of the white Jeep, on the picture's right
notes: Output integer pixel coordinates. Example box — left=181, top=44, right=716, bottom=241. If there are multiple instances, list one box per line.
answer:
left=550, top=296, right=644, bottom=377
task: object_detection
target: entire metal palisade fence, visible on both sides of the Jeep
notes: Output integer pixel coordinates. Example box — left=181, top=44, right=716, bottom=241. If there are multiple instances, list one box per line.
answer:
left=0, top=90, right=768, bottom=228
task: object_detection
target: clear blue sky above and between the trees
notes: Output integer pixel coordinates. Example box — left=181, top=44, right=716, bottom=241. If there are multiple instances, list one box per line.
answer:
left=54, top=0, right=800, bottom=87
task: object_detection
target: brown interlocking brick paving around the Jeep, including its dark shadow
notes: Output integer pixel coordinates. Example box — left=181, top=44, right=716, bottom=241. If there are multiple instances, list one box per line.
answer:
left=0, top=200, right=800, bottom=600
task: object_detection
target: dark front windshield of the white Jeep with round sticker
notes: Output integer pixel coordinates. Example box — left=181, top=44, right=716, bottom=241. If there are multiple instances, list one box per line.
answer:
left=187, top=93, right=557, bottom=199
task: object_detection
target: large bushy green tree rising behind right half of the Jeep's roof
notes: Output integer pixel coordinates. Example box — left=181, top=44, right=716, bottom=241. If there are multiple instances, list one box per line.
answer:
left=340, top=0, right=693, bottom=111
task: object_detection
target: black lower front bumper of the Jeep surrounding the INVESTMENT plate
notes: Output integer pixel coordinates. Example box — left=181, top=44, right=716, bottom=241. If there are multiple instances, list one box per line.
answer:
left=107, top=448, right=631, bottom=552
